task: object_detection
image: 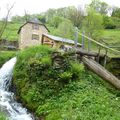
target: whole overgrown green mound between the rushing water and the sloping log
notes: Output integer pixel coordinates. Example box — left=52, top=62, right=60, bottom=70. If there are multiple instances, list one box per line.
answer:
left=13, top=46, right=120, bottom=120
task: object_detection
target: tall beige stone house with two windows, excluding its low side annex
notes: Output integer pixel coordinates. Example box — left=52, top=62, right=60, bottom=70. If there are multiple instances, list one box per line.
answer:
left=18, top=19, right=49, bottom=49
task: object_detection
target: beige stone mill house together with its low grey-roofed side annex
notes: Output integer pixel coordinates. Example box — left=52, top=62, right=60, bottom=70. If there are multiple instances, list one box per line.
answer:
left=18, top=19, right=81, bottom=49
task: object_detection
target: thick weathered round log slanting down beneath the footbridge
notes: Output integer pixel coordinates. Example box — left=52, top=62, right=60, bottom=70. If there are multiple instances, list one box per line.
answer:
left=82, top=56, right=120, bottom=89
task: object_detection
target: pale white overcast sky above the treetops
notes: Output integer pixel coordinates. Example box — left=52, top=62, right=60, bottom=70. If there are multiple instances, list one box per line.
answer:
left=0, top=0, right=120, bottom=18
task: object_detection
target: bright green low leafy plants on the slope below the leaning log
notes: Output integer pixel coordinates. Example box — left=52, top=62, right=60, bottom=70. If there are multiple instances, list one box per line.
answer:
left=37, top=72, right=120, bottom=120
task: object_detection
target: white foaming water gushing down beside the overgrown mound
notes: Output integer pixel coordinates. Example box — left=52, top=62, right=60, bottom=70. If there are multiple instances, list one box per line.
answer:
left=0, top=57, right=34, bottom=120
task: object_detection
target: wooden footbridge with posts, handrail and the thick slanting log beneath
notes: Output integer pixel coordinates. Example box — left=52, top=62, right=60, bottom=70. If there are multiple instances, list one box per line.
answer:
left=72, top=33, right=120, bottom=89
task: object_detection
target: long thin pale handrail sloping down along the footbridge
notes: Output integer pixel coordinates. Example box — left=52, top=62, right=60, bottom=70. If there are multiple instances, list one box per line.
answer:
left=78, top=32, right=120, bottom=54
